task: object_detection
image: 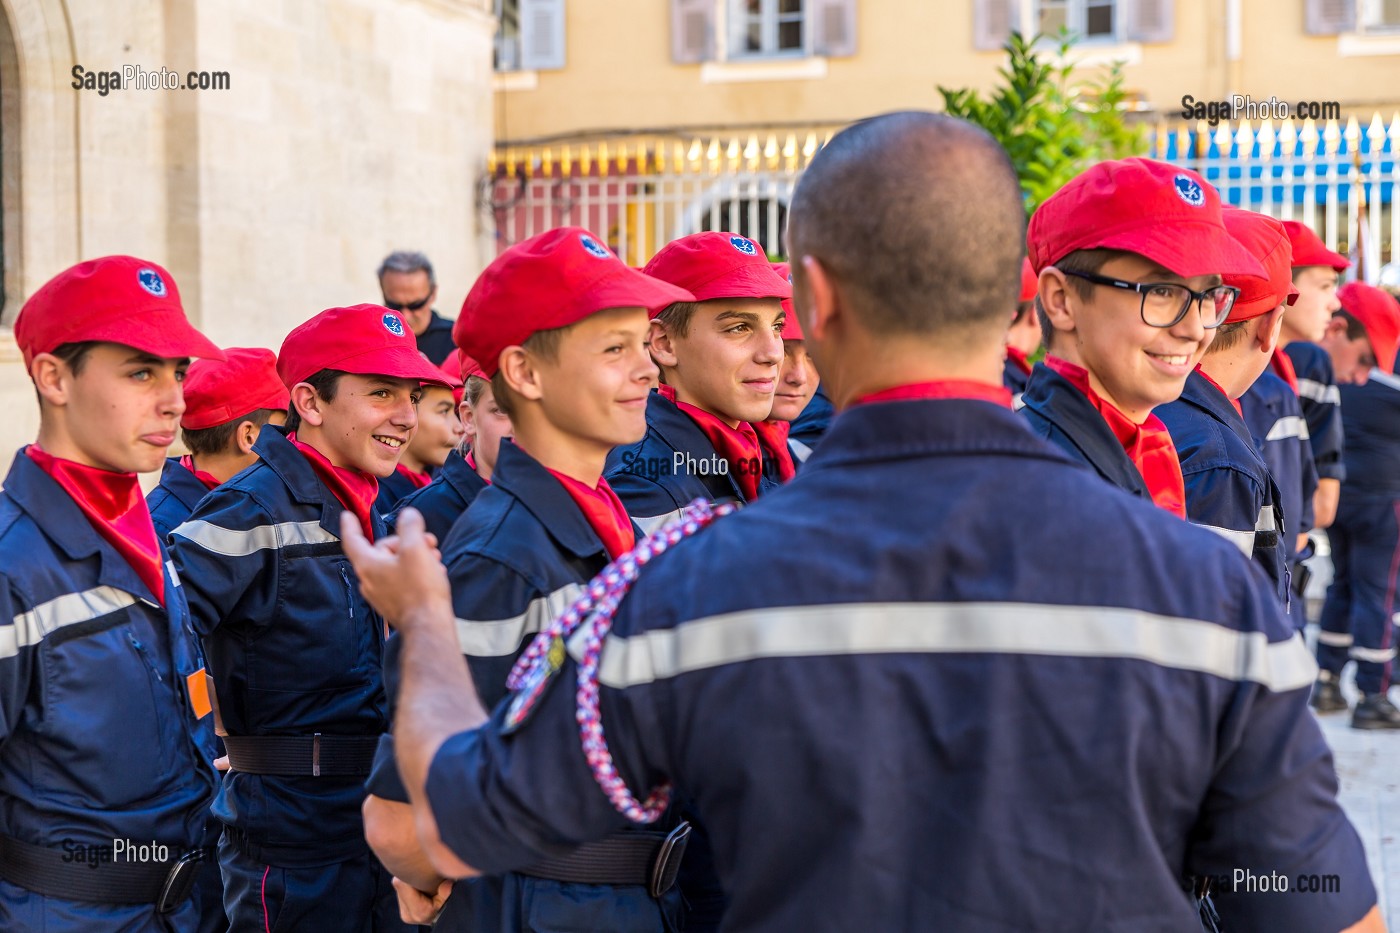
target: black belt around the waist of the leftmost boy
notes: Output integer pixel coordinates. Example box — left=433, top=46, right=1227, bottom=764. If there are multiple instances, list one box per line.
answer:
left=0, top=835, right=214, bottom=913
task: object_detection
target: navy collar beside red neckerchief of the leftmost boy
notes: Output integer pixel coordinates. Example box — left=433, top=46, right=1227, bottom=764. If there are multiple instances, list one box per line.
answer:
left=4, top=451, right=162, bottom=607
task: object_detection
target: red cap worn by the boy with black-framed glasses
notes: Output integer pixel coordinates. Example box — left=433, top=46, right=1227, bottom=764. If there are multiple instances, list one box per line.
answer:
left=1026, top=158, right=1264, bottom=279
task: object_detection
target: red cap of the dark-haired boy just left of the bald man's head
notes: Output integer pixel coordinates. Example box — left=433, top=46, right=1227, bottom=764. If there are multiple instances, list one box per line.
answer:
left=645, top=233, right=792, bottom=301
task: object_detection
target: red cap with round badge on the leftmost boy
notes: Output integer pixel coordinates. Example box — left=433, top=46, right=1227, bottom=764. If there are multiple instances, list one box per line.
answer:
left=14, top=256, right=224, bottom=368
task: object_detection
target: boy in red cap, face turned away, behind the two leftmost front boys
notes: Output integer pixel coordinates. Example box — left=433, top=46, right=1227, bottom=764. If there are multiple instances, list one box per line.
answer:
left=146, top=346, right=291, bottom=541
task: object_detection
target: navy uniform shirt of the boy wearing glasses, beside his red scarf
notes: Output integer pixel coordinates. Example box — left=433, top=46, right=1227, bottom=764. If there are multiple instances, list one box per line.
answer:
left=1021, top=363, right=1152, bottom=502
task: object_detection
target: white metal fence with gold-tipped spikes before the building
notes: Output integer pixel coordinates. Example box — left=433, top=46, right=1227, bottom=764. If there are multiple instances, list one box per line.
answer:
left=479, top=113, right=1400, bottom=270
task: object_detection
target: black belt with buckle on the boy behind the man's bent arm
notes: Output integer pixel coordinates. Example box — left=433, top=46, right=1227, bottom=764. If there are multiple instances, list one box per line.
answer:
left=519, top=822, right=690, bottom=898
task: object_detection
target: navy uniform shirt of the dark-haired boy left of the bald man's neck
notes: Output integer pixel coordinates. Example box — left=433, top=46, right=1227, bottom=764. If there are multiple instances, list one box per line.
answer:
left=603, top=389, right=778, bottom=534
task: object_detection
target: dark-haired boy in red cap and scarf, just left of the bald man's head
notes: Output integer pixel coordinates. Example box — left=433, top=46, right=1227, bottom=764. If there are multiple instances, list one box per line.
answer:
left=606, top=233, right=792, bottom=531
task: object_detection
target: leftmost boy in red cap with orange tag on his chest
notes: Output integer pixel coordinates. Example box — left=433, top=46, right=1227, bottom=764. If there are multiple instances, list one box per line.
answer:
left=0, top=256, right=223, bottom=933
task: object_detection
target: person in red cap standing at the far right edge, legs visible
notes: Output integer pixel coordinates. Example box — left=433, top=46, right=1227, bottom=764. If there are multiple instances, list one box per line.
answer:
left=1312, top=282, right=1400, bottom=730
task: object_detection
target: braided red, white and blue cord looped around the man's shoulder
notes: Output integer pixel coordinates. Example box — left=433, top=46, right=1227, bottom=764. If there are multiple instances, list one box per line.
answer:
left=505, top=499, right=739, bottom=822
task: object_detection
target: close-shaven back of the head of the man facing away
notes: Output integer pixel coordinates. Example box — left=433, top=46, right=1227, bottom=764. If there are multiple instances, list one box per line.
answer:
left=788, top=111, right=1026, bottom=336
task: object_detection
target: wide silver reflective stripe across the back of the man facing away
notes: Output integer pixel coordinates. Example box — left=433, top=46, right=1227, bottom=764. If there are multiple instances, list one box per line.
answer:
left=582, top=602, right=1317, bottom=691
